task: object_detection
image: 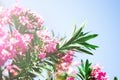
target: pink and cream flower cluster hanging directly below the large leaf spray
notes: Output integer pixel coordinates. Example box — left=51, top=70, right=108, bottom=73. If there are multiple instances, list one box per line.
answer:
left=56, top=51, right=76, bottom=80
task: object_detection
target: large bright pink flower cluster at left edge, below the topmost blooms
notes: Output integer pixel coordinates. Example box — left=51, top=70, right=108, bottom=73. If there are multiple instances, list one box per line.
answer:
left=0, top=28, right=32, bottom=66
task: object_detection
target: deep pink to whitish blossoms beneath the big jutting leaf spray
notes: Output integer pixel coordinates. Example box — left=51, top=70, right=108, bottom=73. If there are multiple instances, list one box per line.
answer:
left=57, top=51, right=76, bottom=77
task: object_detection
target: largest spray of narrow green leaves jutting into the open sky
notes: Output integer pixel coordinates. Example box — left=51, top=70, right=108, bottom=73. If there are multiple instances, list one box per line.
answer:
left=58, top=24, right=98, bottom=55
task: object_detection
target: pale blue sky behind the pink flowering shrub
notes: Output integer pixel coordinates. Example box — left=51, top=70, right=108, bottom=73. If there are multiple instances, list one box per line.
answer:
left=0, top=0, right=120, bottom=79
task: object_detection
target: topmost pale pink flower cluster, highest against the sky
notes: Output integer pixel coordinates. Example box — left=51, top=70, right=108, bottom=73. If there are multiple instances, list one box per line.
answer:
left=0, top=4, right=44, bottom=29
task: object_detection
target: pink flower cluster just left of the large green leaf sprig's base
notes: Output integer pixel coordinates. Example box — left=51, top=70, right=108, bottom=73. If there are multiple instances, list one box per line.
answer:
left=37, top=30, right=59, bottom=59
